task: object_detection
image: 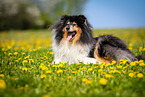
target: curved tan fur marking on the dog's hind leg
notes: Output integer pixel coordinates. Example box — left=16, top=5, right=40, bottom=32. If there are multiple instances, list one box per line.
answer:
left=94, top=43, right=112, bottom=63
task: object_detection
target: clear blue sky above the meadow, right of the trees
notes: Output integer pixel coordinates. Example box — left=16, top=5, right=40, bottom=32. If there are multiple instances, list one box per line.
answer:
left=82, top=0, right=145, bottom=28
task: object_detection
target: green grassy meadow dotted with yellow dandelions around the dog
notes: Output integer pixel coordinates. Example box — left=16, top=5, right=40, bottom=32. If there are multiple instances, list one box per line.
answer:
left=0, top=28, right=145, bottom=97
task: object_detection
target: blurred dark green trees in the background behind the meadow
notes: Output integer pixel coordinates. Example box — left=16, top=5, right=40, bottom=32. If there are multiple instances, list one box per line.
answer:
left=0, top=0, right=86, bottom=30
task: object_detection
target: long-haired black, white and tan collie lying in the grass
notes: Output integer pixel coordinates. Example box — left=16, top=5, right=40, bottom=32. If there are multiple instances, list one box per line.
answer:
left=51, top=15, right=144, bottom=64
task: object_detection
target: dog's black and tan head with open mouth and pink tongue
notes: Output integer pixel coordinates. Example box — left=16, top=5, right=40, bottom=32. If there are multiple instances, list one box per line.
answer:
left=51, top=15, right=92, bottom=43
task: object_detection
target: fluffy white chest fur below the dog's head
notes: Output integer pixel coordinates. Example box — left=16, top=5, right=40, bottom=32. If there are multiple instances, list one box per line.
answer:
left=52, top=41, right=91, bottom=64
